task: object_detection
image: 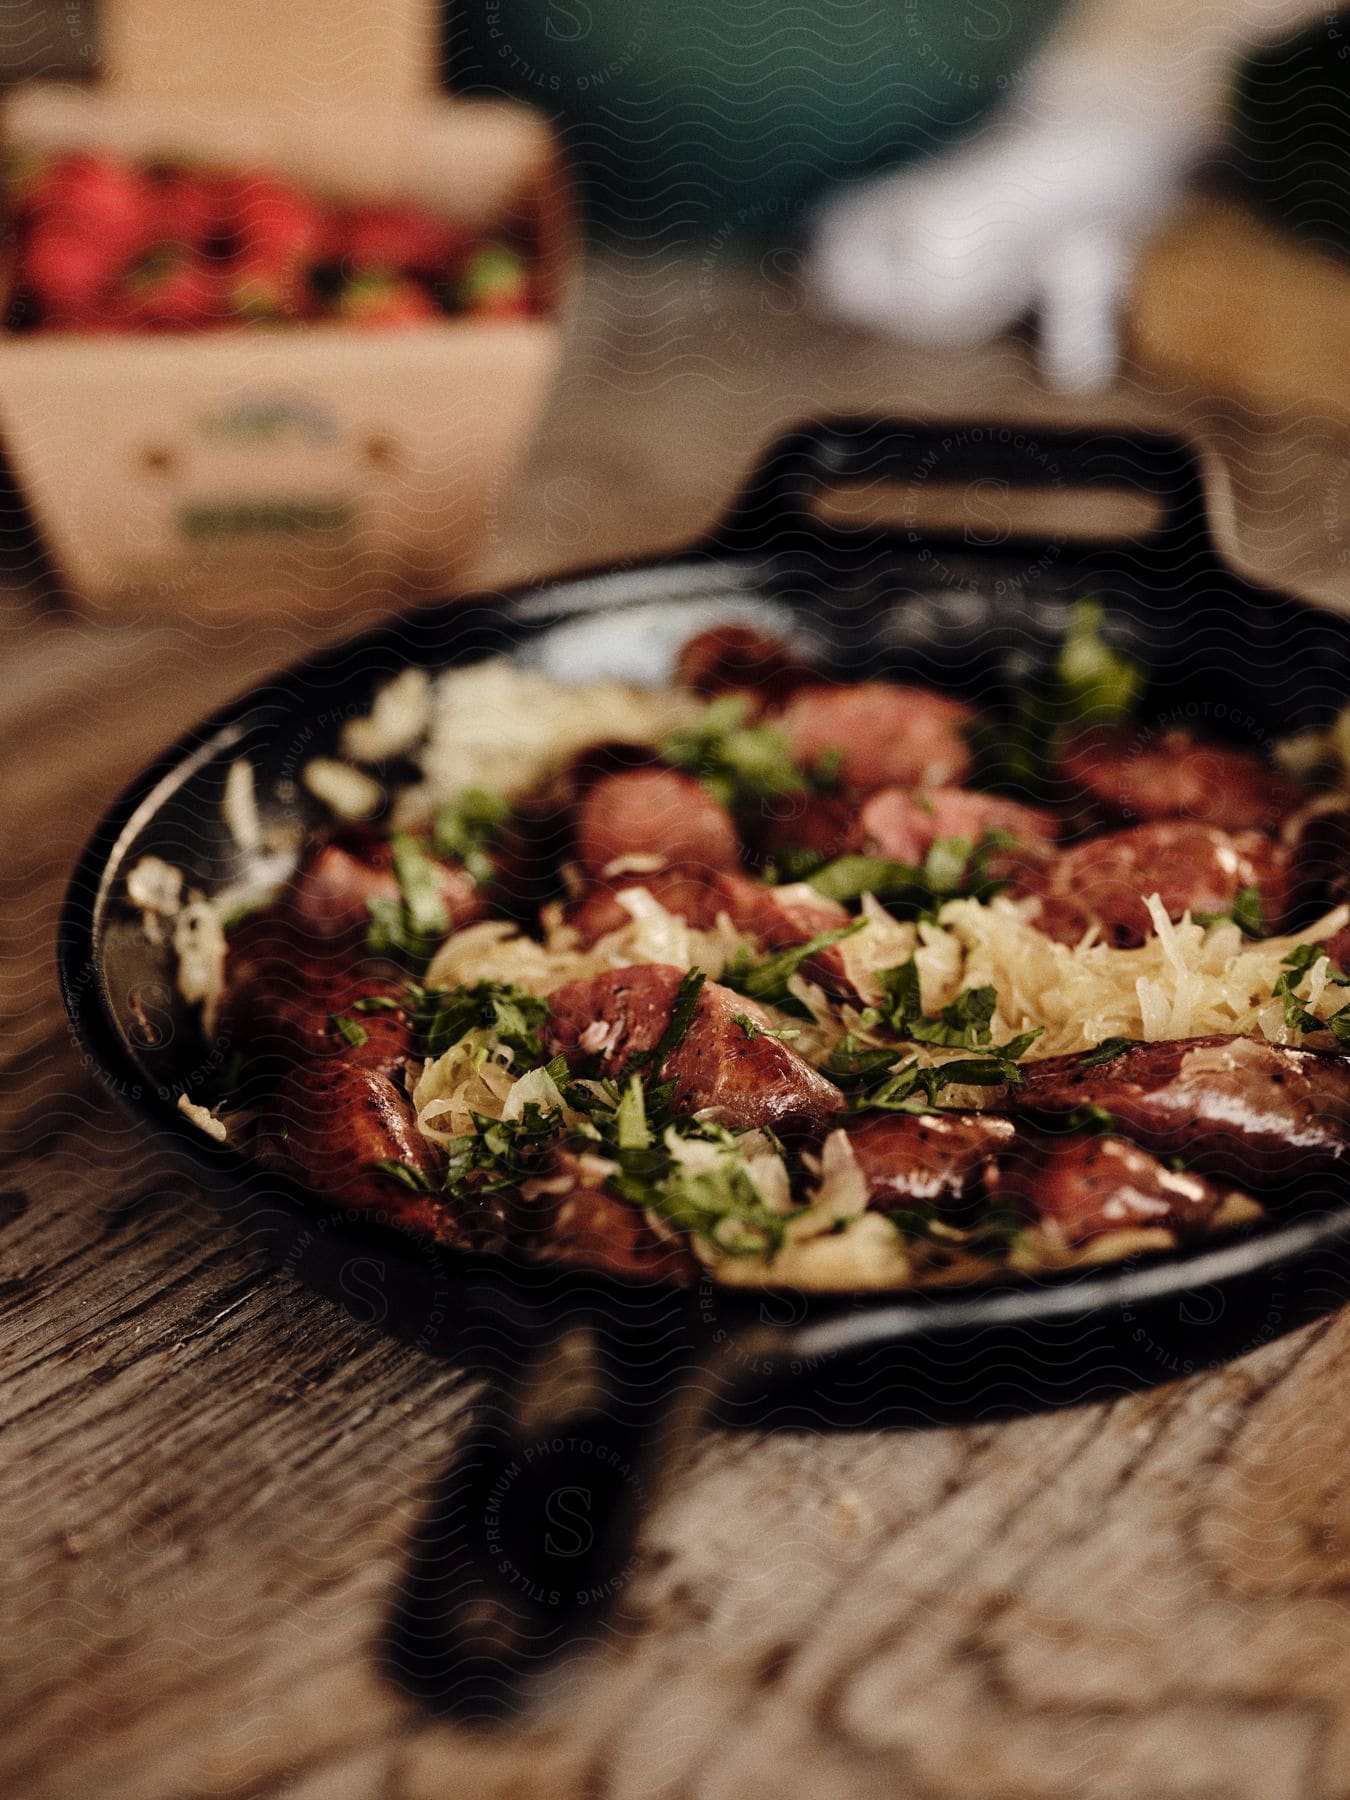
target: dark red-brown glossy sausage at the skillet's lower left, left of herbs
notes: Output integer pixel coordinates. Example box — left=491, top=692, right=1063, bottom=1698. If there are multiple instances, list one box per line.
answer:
left=266, top=1058, right=464, bottom=1244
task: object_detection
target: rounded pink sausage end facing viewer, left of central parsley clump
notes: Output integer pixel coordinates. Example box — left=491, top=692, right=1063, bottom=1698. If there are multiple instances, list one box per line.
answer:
left=576, top=769, right=740, bottom=875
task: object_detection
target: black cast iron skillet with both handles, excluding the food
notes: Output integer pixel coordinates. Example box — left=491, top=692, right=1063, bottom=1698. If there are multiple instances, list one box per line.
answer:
left=59, top=419, right=1350, bottom=1714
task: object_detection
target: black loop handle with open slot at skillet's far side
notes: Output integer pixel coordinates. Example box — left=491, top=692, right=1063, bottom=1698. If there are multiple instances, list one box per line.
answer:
left=713, top=418, right=1210, bottom=563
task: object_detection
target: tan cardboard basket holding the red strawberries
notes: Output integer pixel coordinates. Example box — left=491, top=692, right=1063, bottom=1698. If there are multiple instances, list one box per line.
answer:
left=0, top=86, right=569, bottom=614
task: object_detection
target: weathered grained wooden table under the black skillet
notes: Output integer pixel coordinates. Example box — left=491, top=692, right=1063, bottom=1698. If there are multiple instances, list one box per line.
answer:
left=0, top=265, right=1350, bottom=1800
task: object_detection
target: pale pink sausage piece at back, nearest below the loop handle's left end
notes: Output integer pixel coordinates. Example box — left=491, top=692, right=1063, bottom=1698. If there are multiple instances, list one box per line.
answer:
left=778, top=680, right=974, bottom=792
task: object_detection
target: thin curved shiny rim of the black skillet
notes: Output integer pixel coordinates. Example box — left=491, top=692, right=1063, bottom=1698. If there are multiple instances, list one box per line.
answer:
left=56, top=544, right=1350, bottom=1354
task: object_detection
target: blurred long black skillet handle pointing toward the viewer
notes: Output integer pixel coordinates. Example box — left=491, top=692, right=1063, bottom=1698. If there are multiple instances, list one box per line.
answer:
left=385, top=1319, right=777, bottom=1723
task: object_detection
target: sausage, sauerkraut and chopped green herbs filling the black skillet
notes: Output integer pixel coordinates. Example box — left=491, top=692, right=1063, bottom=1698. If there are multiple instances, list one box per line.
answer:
left=128, top=603, right=1350, bottom=1289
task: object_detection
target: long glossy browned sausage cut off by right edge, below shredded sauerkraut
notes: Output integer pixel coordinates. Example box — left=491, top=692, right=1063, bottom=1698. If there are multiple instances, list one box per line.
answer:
left=1010, top=1037, right=1350, bottom=1188
